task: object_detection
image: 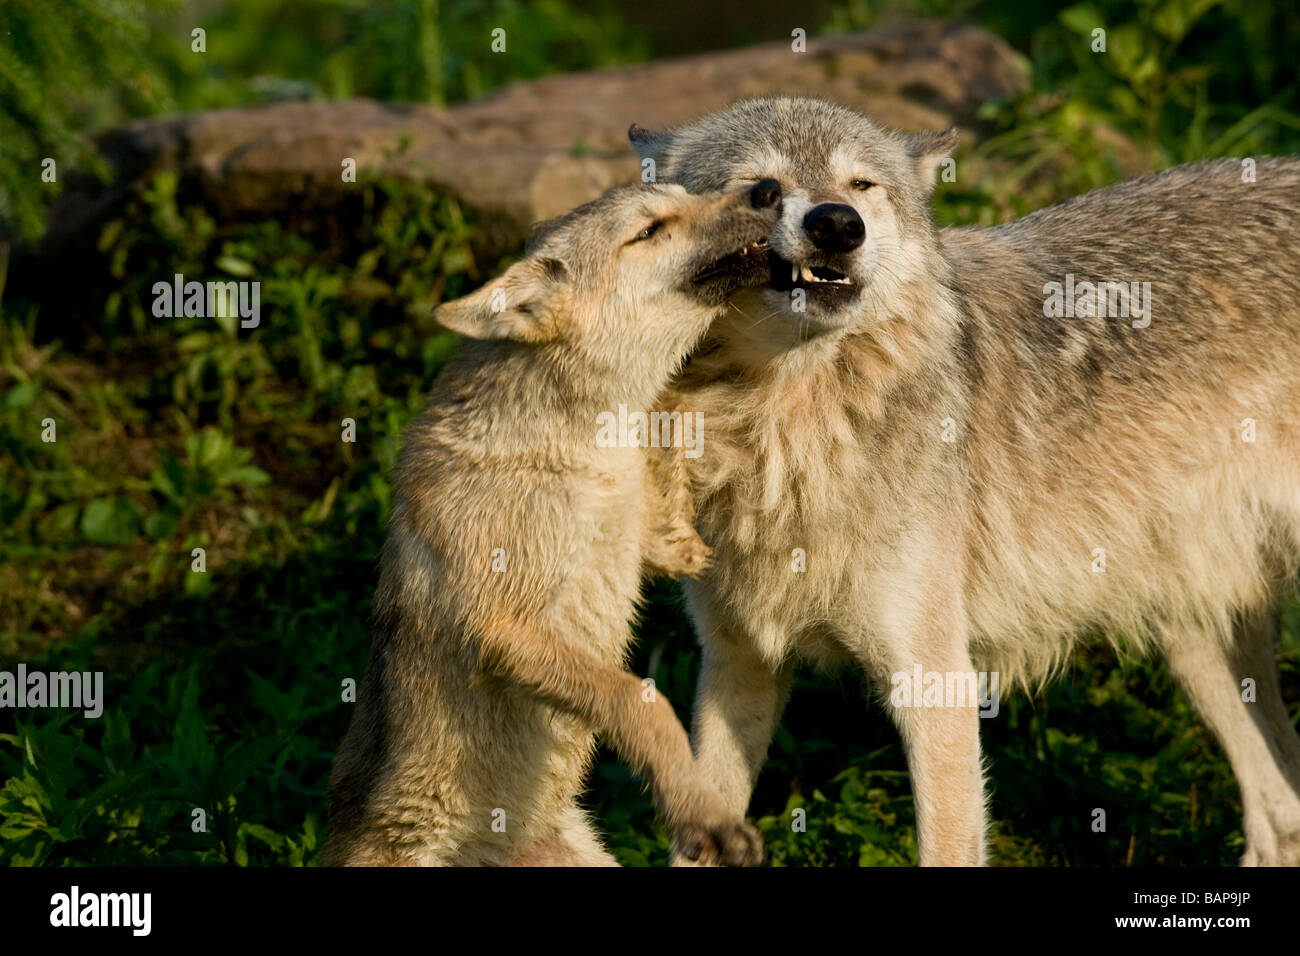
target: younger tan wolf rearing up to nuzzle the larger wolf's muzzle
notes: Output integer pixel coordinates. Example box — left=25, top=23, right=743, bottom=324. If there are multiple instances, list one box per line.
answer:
left=322, top=182, right=780, bottom=865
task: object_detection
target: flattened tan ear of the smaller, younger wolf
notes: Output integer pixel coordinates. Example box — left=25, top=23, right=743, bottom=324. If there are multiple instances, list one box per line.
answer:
left=433, top=258, right=568, bottom=342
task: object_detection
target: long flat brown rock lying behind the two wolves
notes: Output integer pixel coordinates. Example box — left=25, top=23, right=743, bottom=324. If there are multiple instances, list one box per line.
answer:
left=48, top=21, right=1027, bottom=252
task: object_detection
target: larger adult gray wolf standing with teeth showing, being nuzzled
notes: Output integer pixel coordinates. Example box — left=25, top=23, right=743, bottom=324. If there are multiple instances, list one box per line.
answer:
left=629, top=98, right=1300, bottom=865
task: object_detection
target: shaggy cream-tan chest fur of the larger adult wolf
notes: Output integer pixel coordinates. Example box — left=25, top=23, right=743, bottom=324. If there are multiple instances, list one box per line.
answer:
left=685, top=330, right=962, bottom=663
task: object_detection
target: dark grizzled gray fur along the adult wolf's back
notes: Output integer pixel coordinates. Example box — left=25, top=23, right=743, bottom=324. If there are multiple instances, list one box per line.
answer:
left=940, top=157, right=1300, bottom=408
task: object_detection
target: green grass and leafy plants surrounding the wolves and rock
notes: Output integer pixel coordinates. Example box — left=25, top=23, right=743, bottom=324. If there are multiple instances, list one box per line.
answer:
left=0, top=0, right=1300, bottom=866
